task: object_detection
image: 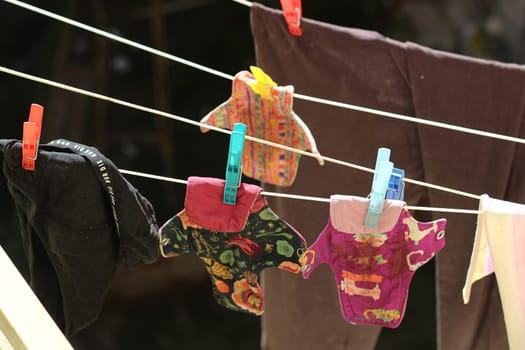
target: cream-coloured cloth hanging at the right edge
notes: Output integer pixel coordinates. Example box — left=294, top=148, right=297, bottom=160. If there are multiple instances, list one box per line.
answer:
left=463, top=194, right=525, bottom=350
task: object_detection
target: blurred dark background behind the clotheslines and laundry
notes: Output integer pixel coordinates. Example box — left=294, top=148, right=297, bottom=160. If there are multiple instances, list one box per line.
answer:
left=0, top=0, right=525, bottom=350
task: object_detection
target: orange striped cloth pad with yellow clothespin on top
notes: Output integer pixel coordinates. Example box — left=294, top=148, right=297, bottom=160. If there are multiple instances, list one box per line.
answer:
left=201, top=67, right=323, bottom=186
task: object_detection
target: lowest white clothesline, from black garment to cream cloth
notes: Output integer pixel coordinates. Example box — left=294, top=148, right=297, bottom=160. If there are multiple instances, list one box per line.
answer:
left=119, top=169, right=480, bottom=215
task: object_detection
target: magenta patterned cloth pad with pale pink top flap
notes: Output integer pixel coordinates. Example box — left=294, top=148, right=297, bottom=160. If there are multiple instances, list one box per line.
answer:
left=300, top=195, right=446, bottom=328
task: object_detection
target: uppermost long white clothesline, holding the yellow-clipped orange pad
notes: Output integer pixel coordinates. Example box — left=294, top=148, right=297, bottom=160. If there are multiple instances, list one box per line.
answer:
left=3, top=0, right=525, bottom=144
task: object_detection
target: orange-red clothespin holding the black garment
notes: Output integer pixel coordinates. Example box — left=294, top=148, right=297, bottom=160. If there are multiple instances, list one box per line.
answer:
left=22, top=103, right=44, bottom=170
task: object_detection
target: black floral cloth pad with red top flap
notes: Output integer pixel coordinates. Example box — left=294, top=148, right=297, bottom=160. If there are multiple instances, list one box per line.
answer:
left=160, top=177, right=306, bottom=315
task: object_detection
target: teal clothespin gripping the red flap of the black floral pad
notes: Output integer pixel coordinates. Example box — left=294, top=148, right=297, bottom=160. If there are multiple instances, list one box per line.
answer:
left=223, top=123, right=246, bottom=205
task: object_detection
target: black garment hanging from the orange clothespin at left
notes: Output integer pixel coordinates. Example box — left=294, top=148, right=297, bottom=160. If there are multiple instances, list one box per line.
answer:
left=0, top=140, right=160, bottom=335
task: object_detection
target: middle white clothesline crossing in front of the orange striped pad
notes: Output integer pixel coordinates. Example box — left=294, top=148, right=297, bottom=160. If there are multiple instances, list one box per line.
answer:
left=0, top=66, right=481, bottom=200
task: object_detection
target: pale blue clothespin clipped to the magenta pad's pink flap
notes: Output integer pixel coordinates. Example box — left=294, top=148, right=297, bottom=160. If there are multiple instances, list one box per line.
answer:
left=365, top=147, right=394, bottom=227
